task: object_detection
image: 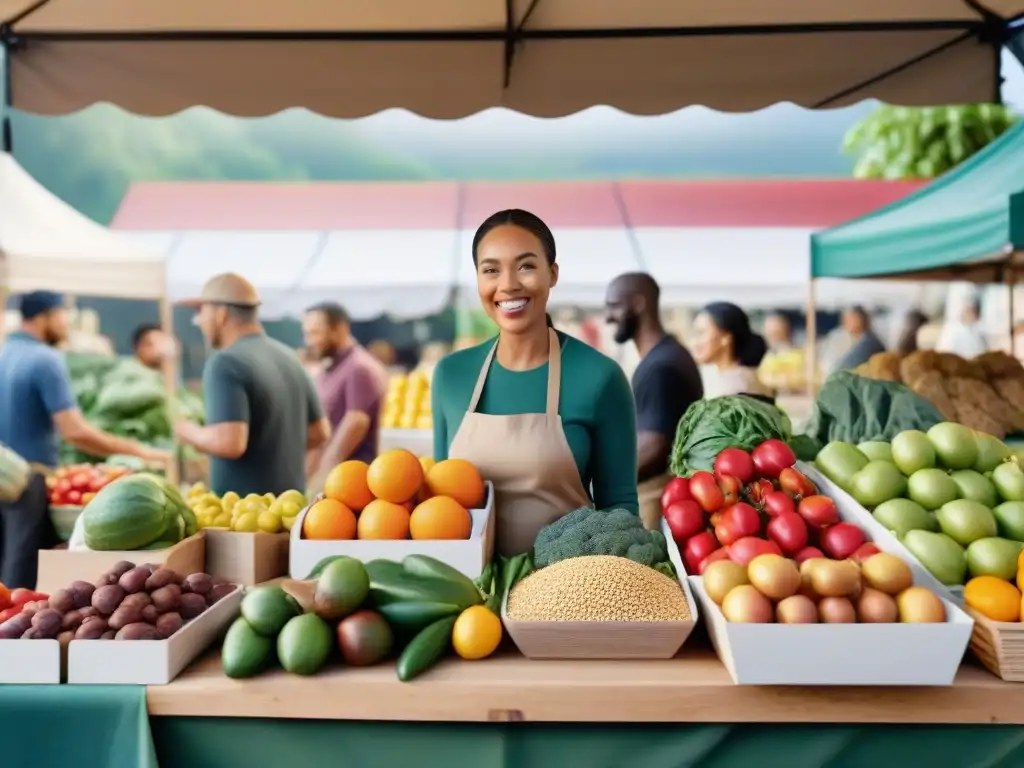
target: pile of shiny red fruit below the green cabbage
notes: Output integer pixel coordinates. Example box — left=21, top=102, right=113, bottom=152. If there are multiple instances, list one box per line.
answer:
left=662, top=439, right=879, bottom=573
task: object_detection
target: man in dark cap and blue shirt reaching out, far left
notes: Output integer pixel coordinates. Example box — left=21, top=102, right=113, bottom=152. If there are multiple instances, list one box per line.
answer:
left=0, top=291, right=169, bottom=588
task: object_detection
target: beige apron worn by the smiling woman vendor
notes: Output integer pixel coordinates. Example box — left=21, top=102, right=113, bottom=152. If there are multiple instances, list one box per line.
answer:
left=449, top=331, right=591, bottom=556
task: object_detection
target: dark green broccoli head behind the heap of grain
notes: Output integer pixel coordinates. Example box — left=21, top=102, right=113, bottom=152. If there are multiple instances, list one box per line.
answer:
left=534, top=507, right=669, bottom=568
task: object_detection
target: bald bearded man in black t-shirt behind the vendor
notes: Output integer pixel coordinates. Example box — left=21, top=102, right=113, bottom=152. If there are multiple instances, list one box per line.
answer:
left=605, top=272, right=703, bottom=527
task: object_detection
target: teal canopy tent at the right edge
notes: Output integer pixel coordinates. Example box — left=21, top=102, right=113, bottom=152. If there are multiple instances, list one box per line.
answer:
left=811, top=118, right=1024, bottom=283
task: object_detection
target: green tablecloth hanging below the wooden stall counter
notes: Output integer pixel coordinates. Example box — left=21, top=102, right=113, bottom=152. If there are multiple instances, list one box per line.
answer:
left=6, top=685, right=1024, bottom=768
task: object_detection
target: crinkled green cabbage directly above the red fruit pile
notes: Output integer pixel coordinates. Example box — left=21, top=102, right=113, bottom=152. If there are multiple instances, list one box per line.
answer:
left=669, top=394, right=793, bottom=477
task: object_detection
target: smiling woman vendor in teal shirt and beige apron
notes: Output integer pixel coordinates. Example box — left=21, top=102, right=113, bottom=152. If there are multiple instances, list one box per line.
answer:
left=431, top=210, right=638, bottom=555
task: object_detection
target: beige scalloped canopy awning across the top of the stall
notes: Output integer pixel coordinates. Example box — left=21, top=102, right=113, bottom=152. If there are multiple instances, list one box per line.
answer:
left=0, top=0, right=1024, bottom=118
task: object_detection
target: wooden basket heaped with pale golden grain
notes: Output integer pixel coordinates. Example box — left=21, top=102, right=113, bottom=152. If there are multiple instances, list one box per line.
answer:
left=502, top=555, right=697, bottom=658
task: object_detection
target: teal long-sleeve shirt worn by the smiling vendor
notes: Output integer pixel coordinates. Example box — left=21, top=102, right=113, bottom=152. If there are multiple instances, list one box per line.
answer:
left=431, top=333, right=639, bottom=514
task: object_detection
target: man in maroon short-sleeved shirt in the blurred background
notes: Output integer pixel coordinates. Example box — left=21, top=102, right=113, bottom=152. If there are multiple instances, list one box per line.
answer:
left=302, top=302, right=387, bottom=489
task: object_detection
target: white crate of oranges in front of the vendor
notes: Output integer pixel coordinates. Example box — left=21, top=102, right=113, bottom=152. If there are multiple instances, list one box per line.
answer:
left=289, top=449, right=495, bottom=579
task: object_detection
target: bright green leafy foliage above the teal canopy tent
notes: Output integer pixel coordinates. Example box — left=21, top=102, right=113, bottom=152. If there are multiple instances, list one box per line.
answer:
left=843, top=104, right=1018, bottom=179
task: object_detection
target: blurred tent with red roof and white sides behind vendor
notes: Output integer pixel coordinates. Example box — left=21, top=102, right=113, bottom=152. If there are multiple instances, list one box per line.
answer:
left=113, top=180, right=919, bottom=318
